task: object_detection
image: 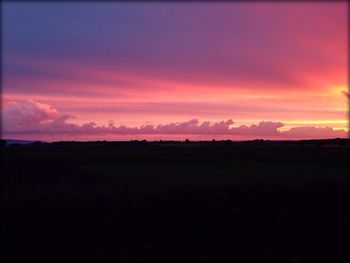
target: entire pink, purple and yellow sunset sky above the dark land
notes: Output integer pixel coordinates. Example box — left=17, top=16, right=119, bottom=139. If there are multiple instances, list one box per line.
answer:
left=1, top=1, right=349, bottom=141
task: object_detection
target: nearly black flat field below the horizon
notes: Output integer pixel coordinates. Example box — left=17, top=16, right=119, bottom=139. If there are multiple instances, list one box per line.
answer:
left=1, top=140, right=349, bottom=263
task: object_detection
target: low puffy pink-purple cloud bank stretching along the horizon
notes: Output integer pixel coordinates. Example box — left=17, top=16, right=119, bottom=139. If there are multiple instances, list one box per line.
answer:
left=2, top=100, right=348, bottom=139
